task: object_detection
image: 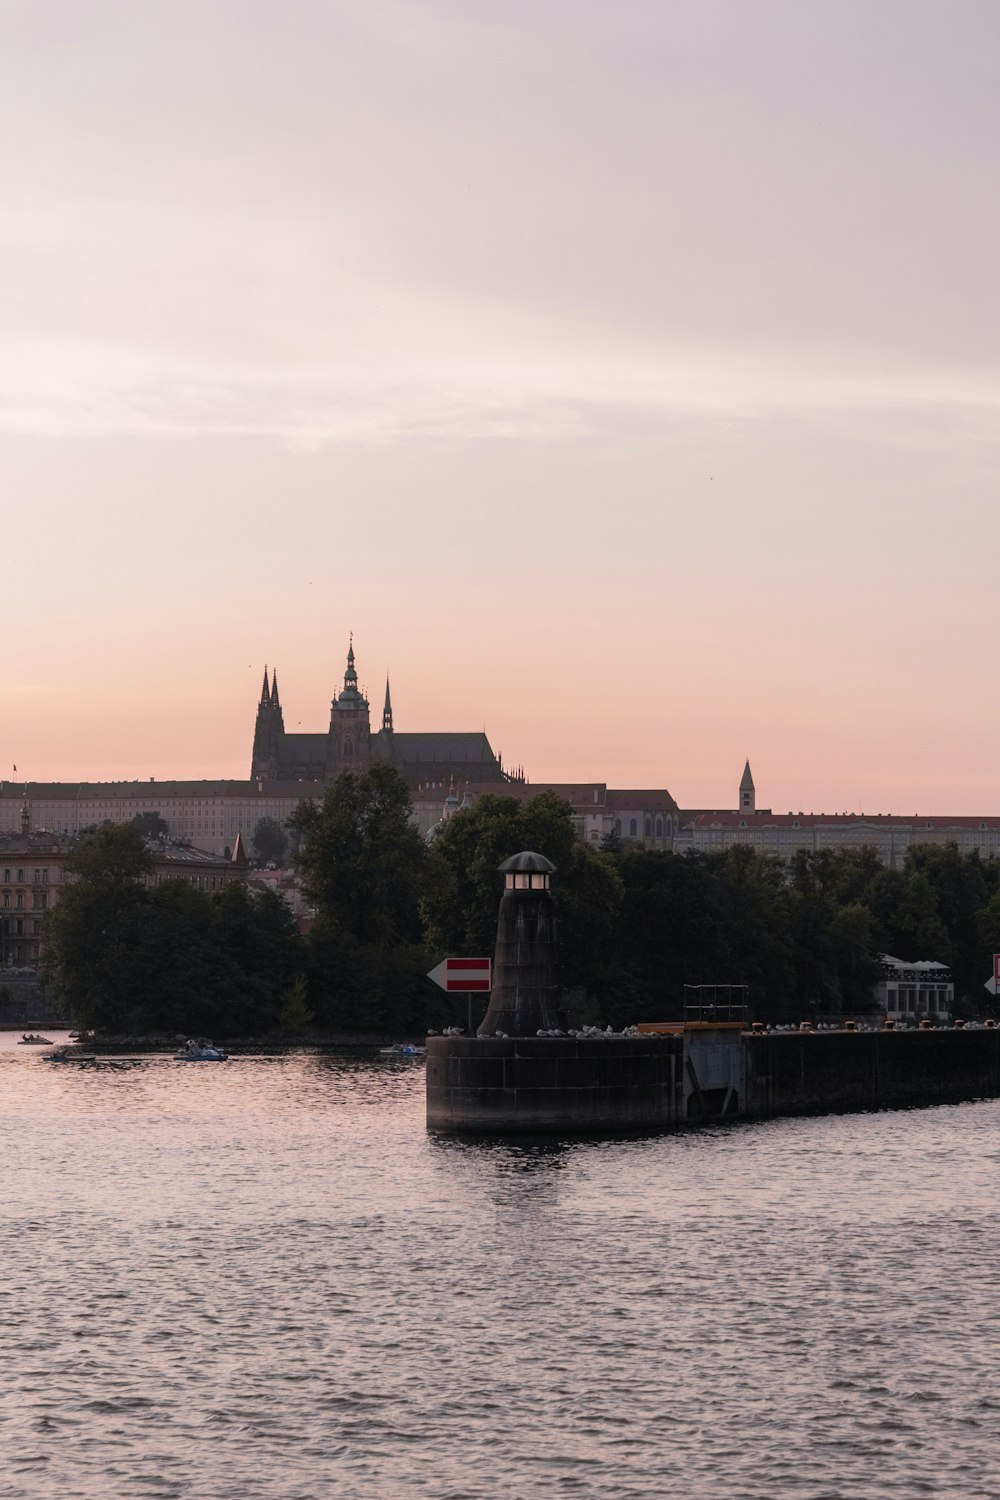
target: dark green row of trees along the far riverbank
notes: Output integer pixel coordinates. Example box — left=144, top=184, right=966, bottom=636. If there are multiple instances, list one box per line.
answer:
left=43, top=765, right=1000, bottom=1037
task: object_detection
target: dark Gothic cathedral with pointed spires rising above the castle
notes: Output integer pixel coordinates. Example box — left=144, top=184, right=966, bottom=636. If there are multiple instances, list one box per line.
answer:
left=250, top=642, right=523, bottom=789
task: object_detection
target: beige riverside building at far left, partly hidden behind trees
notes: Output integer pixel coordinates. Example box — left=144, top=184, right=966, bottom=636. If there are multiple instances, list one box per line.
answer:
left=0, top=828, right=247, bottom=969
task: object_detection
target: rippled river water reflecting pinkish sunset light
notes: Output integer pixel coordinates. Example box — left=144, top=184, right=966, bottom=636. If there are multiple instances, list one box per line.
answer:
left=0, top=1037, right=1000, bottom=1500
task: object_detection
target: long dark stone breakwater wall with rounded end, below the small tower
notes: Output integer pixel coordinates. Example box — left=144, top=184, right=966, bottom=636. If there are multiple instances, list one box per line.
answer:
left=427, top=1025, right=1000, bottom=1134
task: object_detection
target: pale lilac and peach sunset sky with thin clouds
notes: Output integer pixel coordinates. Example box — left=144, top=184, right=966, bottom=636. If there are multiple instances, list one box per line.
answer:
left=0, top=0, right=1000, bottom=815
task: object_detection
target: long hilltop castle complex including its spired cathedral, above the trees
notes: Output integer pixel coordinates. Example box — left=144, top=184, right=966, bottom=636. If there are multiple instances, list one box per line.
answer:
left=0, top=644, right=1000, bottom=864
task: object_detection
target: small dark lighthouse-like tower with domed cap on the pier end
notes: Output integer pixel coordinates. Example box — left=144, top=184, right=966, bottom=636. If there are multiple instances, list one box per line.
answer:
left=478, top=851, right=564, bottom=1037
